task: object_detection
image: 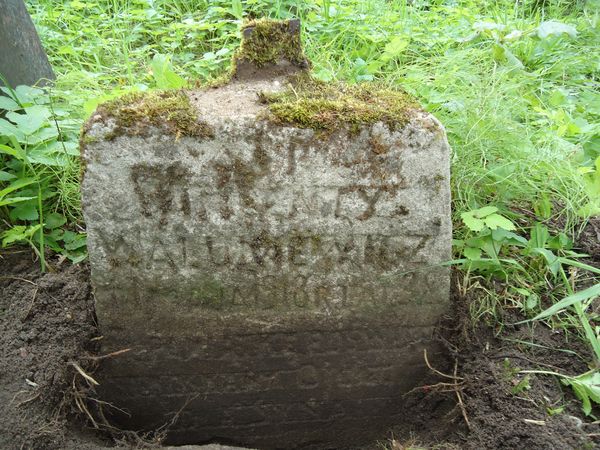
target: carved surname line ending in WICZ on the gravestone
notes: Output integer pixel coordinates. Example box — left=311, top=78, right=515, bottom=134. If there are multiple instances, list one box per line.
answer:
left=103, top=230, right=432, bottom=274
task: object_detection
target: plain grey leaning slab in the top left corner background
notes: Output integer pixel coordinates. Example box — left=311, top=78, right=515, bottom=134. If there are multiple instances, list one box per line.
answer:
left=0, top=0, right=55, bottom=87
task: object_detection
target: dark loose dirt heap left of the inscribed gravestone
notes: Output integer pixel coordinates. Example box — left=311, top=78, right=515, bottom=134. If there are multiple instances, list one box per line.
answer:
left=0, top=250, right=104, bottom=450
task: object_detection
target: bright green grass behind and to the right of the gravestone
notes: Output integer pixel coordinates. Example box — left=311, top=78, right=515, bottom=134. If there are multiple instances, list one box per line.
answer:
left=24, top=0, right=600, bottom=227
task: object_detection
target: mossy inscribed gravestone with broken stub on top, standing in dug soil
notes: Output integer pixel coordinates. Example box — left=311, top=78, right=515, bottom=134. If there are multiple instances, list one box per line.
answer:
left=82, top=21, right=451, bottom=449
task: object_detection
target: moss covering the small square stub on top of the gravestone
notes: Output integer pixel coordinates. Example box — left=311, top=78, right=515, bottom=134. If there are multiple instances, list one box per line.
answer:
left=234, top=19, right=307, bottom=67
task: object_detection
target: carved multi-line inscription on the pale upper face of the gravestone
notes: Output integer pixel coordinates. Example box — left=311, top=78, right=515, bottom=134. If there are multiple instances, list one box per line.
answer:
left=89, top=119, right=450, bottom=310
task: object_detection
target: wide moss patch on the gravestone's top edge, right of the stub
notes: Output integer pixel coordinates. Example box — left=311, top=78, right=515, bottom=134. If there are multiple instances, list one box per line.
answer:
left=260, top=73, right=419, bottom=132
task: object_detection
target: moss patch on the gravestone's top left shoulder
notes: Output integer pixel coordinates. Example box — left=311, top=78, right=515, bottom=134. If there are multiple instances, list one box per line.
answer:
left=98, top=91, right=214, bottom=139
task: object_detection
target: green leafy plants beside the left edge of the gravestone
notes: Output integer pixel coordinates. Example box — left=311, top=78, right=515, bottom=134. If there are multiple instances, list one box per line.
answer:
left=0, top=86, right=86, bottom=270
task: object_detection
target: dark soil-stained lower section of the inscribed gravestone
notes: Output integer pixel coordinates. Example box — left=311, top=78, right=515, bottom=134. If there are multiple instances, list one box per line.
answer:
left=99, top=319, right=446, bottom=449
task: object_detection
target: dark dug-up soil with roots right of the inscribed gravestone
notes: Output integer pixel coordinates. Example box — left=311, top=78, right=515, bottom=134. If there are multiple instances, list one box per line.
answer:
left=396, top=270, right=600, bottom=450
